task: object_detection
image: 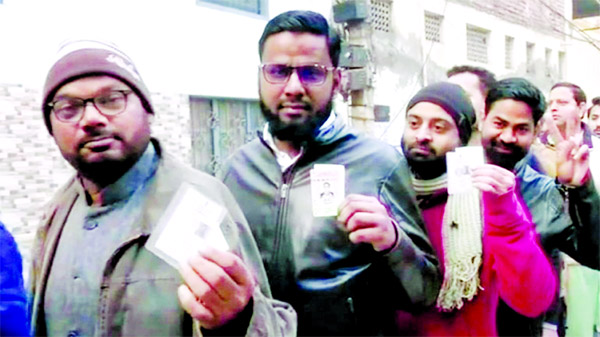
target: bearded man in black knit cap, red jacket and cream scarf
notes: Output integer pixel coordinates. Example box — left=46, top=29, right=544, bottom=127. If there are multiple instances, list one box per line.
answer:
left=397, top=83, right=556, bottom=336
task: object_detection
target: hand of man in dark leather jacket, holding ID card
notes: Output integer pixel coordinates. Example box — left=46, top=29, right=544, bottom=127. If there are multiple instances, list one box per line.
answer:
left=337, top=194, right=396, bottom=252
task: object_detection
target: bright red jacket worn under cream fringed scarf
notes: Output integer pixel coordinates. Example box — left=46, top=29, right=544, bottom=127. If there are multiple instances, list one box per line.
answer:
left=396, top=192, right=557, bottom=336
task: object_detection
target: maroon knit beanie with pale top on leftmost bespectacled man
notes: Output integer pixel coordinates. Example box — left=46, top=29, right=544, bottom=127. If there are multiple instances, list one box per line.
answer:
left=42, top=40, right=154, bottom=134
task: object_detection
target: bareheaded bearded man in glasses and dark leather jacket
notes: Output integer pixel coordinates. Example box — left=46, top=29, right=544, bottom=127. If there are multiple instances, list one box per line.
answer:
left=222, top=11, right=440, bottom=336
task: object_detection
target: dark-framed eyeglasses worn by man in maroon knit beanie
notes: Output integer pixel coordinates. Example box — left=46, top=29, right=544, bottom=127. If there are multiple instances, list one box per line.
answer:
left=48, top=90, right=132, bottom=123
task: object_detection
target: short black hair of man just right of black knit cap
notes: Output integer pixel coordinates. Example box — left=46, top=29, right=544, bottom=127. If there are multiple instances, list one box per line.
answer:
left=485, top=77, right=546, bottom=125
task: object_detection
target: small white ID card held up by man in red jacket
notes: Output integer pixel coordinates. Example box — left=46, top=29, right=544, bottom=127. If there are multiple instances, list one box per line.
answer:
left=446, top=146, right=484, bottom=195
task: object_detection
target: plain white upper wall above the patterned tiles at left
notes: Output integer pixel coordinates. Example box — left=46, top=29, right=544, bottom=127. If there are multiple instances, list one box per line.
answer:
left=0, top=0, right=331, bottom=98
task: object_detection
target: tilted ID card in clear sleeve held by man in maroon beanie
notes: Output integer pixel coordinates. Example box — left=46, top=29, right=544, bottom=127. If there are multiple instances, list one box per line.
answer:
left=146, top=183, right=229, bottom=268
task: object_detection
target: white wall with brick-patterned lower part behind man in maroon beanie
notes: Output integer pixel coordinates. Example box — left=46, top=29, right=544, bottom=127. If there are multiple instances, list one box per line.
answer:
left=0, top=0, right=331, bottom=272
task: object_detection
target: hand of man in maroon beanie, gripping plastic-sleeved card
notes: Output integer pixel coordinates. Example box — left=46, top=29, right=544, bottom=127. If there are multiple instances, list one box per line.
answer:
left=177, top=248, right=255, bottom=329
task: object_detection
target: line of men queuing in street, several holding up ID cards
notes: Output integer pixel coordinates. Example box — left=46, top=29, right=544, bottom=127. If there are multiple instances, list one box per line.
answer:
left=0, top=11, right=600, bottom=336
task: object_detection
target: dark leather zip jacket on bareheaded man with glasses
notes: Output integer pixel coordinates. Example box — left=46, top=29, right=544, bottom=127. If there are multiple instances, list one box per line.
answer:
left=222, top=119, right=441, bottom=336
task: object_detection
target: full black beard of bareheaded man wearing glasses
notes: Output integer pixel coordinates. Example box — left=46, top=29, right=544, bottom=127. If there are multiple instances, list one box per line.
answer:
left=260, top=99, right=333, bottom=144
